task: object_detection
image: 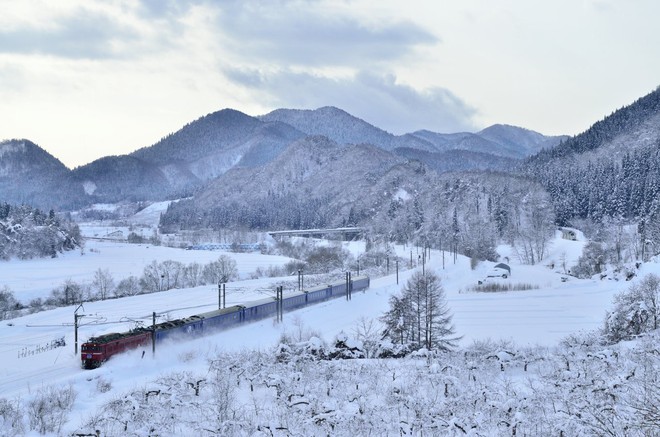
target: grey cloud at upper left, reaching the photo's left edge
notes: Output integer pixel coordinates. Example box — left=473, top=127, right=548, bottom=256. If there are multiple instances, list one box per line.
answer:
left=0, top=10, right=137, bottom=59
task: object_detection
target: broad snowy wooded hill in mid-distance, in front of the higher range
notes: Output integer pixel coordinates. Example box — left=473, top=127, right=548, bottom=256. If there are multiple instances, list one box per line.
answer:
left=160, top=136, right=542, bottom=259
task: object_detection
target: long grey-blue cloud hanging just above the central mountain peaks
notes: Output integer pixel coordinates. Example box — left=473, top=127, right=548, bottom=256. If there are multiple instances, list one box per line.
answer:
left=226, top=70, right=477, bottom=134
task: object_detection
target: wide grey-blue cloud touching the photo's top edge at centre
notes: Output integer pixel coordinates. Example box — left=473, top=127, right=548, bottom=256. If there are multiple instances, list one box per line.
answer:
left=213, top=1, right=438, bottom=66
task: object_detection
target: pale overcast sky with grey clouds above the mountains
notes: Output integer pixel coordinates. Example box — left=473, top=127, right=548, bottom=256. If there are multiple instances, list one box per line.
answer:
left=0, top=0, right=660, bottom=168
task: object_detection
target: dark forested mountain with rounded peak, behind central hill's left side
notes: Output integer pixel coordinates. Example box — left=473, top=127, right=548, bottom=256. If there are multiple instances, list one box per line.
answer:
left=73, top=109, right=303, bottom=202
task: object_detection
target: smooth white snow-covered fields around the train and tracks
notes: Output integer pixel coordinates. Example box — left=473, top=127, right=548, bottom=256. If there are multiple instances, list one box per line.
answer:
left=0, top=223, right=660, bottom=426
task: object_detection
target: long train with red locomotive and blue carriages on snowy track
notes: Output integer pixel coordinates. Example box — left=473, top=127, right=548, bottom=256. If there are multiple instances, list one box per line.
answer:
left=81, top=276, right=369, bottom=369
